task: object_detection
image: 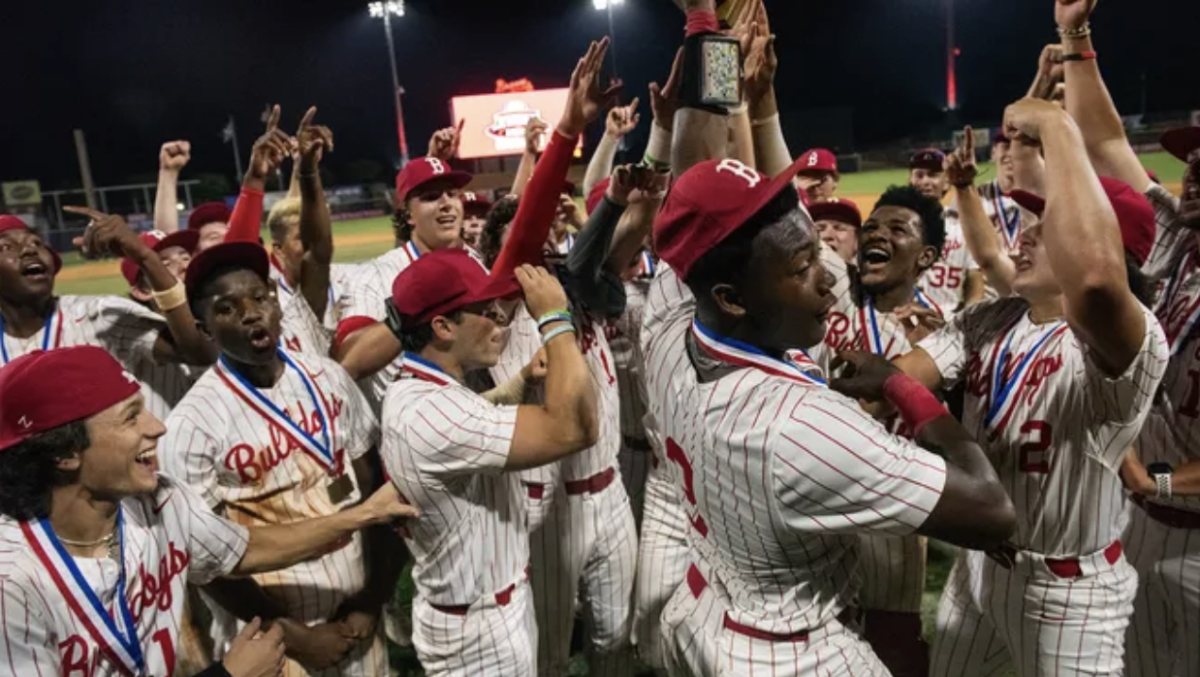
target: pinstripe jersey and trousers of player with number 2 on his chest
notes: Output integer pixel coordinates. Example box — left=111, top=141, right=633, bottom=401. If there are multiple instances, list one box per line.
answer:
left=920, top=298, right=1166, bottom=676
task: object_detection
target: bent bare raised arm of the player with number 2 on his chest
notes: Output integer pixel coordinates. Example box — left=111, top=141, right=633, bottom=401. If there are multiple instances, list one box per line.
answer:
left=1004, top=99, right=1146, bottom=376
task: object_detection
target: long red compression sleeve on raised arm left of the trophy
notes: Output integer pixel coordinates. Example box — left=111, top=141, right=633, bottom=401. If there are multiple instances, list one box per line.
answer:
left=492, top=130, right=577, bottom=277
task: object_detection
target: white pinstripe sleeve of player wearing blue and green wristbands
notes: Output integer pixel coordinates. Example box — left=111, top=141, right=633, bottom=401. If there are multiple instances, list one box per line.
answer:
left=397, top=388, right=517, bottom=479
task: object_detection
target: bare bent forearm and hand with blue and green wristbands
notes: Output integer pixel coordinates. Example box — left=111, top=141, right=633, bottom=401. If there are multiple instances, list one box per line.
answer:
left=505, top=265, right=600, bottom=471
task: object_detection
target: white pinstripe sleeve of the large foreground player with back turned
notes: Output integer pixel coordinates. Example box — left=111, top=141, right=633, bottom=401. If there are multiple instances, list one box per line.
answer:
left=772, top=395, right=946, bottom=535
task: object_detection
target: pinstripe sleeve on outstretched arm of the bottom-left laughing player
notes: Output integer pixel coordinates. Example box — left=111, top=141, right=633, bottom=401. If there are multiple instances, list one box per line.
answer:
left=168, top=483, right=250, bottom=586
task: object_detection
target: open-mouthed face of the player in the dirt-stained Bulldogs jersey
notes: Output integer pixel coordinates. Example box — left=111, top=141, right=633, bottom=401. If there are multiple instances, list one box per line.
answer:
left=198, top=269, right=283, bottom=365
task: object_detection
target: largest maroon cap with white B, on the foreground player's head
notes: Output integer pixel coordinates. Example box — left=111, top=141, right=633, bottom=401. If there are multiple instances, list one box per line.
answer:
left=654, top=157, right=806, bottom=280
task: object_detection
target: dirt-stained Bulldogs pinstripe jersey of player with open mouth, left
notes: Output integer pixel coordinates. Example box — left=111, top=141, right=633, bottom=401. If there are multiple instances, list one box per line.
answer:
left=158, top=353, right=379, bottom=622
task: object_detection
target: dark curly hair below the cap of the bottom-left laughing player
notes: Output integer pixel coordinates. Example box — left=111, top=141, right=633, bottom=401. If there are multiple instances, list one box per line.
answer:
left=0, top=420, right=91, bottom=521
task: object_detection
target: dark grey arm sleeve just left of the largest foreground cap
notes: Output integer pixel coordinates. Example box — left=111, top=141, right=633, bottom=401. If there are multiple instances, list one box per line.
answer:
left=566, top=196, right=625, bottom=317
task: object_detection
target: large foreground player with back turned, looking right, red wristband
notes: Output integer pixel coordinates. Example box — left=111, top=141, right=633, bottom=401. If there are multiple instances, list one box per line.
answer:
left=642, top=150, right=1012, bottom=675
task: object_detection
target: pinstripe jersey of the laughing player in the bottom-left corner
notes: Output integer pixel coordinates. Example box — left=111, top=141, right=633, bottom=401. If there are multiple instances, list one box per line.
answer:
left=0, top=475, right=248, bottom=677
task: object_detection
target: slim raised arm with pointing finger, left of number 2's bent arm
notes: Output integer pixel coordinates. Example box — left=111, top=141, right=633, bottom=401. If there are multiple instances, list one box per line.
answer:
left=946, top=127, right=1016, bottom=295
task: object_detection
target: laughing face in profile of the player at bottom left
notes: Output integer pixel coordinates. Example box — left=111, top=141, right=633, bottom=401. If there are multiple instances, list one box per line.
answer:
left=59, top=393, right=167, bottom=499
